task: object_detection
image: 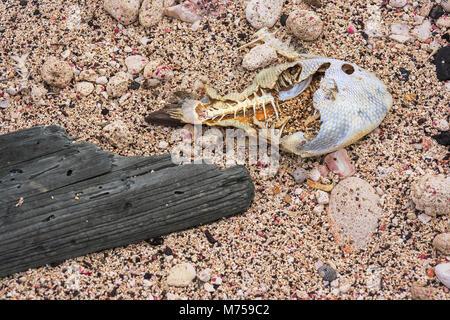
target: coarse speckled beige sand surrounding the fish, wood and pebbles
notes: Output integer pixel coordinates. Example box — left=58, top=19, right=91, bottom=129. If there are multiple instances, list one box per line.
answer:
left=0, top=0, right=450, bottom=300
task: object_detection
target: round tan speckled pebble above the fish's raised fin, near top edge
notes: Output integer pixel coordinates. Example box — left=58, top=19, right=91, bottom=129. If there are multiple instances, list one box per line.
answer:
left=286, top=10, right=323, bottom=41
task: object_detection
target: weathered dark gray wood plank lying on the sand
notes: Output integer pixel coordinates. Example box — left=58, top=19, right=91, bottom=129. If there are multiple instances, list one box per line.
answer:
left=0, top=126, right=254, bottom=277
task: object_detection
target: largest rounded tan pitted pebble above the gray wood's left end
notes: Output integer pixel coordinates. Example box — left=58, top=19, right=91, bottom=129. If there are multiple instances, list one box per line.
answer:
left=41, top=57, right=73, bottom=88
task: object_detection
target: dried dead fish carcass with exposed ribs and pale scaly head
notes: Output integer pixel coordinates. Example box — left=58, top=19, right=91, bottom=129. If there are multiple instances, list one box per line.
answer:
left=148, top=29, right=392, bottom=157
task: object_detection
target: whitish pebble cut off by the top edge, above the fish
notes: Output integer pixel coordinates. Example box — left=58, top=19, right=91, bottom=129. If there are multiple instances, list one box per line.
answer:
left=245, top=0, right=284, bottom=29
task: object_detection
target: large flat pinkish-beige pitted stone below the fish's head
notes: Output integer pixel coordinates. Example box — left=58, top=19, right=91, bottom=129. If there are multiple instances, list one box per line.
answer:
left=329, top=177, right=383, bottom=249
